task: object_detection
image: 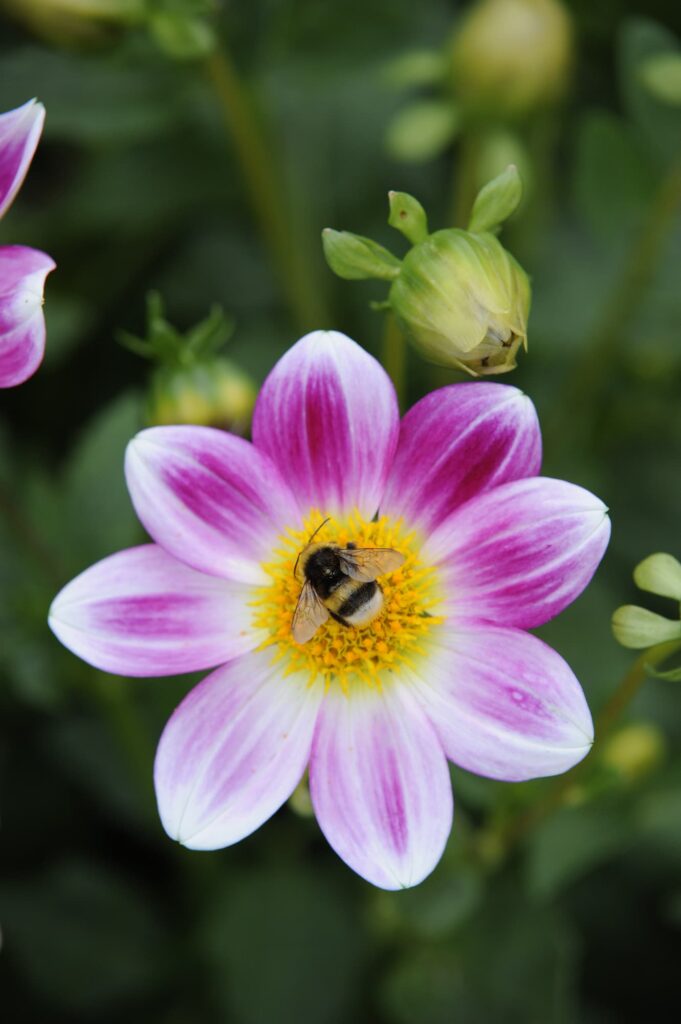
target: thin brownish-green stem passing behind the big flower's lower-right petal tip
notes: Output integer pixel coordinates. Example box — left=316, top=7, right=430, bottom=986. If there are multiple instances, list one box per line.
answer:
left=495, top=641, right=679, bottom=859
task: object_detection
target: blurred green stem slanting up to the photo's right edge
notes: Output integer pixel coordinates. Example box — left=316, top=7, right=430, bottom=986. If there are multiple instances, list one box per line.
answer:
left=560, top=164, right=681, bottom=436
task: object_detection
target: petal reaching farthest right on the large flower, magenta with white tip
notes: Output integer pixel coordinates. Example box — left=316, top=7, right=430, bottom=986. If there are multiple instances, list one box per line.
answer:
left=423, top=477, right=610, bottom=629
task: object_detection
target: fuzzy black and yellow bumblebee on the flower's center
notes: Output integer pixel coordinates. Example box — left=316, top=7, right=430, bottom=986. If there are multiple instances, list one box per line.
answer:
left=291, top=523, right=405, bottom=644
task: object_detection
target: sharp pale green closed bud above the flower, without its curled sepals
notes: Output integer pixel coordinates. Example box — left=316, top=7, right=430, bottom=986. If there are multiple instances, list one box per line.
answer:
left=389, top=228, right=530, bottom=376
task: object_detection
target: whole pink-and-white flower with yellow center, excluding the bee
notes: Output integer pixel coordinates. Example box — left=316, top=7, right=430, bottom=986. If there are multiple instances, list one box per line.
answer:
left=50, top=332, right=609, bottom=889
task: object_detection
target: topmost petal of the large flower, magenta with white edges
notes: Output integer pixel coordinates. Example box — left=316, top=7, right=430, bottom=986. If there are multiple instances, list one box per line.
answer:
left=253, top=331, right=399, bottom=518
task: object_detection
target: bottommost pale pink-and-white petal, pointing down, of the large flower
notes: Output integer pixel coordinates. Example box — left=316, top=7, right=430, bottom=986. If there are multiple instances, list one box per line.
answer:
left=309, top=685, right=454, bottom=889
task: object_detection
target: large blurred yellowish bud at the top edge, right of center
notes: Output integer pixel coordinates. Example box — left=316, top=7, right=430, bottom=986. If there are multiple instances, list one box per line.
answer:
left=452, top=0, right=572, bottom=120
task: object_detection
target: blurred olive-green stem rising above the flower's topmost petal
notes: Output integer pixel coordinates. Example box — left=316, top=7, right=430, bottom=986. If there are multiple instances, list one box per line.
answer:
left=206, top=46, right=328, bottom=330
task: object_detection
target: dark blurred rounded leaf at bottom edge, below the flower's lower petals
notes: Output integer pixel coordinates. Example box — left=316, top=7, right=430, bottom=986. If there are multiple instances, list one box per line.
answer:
left=203, top=864, right=366, bottom=1024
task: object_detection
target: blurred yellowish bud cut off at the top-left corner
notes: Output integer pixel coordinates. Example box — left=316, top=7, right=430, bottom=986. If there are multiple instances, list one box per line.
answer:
left=0, top=0, right=147, bottom=45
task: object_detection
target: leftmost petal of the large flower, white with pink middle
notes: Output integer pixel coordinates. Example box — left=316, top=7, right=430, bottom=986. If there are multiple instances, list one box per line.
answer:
left=49, top=544, right=264, bottom=676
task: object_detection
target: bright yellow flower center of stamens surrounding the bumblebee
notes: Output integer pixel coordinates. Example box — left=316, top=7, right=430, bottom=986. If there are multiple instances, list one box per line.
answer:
left=252, top=509, right=442, bottom=689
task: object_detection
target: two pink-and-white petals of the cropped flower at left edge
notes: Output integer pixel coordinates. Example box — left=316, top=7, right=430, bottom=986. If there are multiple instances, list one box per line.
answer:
left=0, top=99, right=54, bottom=387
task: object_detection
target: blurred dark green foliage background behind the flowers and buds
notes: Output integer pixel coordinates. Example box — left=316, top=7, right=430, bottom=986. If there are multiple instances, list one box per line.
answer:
left=0, top=0, right=681, bottom=1024
